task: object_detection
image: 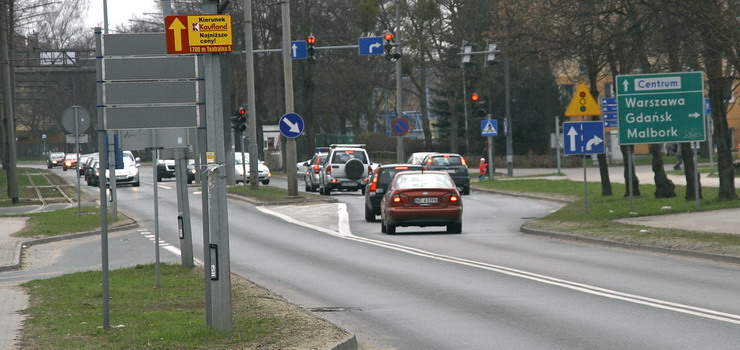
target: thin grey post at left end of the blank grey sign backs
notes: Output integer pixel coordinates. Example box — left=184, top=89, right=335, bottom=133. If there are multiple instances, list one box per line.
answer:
left=95, top=27, right=110, bottom=329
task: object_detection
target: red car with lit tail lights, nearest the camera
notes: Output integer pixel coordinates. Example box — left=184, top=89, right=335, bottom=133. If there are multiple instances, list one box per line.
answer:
left=380, top=171, right=463, bottom=235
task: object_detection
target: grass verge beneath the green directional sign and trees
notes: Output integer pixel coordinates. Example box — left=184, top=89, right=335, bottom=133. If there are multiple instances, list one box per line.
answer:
left=474, top=179, right=740, bottom=257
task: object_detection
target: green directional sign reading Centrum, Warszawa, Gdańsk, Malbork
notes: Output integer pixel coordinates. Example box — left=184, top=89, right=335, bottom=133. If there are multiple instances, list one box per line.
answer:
left=616, top=72, right=706, bottom=145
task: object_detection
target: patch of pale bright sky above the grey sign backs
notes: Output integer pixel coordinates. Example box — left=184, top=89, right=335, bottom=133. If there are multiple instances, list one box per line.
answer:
left=86, top=0, right=159, bottom=32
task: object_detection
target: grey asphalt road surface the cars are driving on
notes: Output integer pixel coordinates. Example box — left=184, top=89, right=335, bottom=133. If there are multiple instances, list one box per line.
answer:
left=47, top=168, right=740, bottom=349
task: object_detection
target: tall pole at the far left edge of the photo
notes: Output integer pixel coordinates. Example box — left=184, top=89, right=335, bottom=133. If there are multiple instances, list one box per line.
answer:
left=0, top=8, right=19, bottom=204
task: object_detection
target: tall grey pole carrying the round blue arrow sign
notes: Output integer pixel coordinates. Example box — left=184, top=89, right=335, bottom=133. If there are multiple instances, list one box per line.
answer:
left=280, top=0, right=298, bottom=196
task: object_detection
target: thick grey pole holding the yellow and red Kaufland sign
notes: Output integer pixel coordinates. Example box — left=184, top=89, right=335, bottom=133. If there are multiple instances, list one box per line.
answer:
left=202, top=0, right=234, bottom=331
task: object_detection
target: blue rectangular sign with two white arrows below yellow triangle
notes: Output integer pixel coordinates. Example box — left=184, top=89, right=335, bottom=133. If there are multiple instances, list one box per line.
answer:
left=563, top=121, right=606, bottom=155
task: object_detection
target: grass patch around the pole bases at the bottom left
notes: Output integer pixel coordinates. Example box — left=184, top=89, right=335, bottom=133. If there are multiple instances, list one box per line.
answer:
left=19, top=264, right=346, bottom=349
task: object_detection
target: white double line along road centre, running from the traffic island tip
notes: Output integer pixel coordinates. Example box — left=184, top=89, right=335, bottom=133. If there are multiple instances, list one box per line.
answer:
left=256, top=203, right=740, bottom=324
